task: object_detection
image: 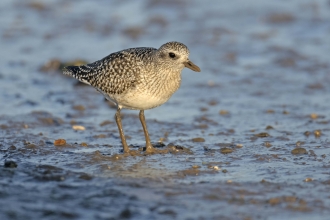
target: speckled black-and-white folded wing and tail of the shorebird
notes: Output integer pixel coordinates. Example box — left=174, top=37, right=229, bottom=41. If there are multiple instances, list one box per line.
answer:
left=64, top=47, right=156, bottom=95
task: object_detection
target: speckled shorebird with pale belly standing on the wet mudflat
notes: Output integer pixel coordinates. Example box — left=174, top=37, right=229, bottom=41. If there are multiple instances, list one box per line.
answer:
left=63, top=41, right=201, bottom=153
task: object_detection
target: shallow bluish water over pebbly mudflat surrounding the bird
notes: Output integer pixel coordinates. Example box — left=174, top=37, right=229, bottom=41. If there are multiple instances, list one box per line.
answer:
left=0, top=0, right=330, bottom=219
